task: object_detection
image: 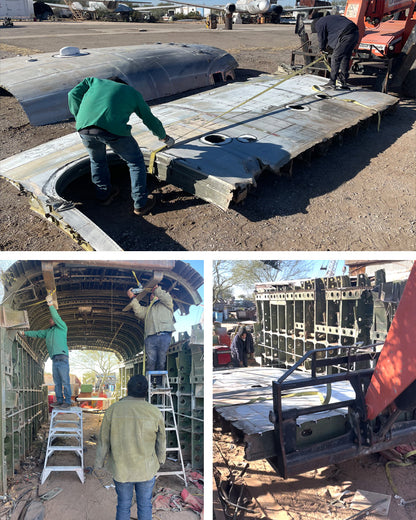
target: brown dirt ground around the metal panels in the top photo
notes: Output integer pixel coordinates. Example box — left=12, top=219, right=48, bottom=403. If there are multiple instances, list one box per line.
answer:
left=0, top=22, right=416, bottom=251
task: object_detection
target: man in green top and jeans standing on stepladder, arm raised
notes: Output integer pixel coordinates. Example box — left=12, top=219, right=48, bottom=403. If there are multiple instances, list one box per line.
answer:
left=20, top=296, right=72, bottom=408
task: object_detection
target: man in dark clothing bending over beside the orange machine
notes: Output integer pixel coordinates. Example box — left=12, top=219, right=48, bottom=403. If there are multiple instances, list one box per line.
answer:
left=311, top=14, right=359, bottom=89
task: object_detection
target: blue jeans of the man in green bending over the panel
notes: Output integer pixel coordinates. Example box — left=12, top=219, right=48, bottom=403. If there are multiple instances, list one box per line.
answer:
left=80, top=131, right=147, bottom=209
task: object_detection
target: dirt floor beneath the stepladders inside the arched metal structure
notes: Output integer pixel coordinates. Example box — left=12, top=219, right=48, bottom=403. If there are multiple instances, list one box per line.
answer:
left=0, top=413, right=203, bottom=520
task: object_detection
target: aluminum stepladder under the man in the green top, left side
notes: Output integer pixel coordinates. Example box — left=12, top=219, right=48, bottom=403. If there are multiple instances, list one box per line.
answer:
left=40, top=406, right=85, bottom=484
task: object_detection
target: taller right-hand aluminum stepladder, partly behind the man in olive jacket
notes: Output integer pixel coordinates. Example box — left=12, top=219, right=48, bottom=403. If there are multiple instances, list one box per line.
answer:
left=146, top=370, right=188, bottom=487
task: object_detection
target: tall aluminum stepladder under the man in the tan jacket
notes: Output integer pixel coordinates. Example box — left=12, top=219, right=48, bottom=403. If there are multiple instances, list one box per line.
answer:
left=146, top=370, right=188, bottom=486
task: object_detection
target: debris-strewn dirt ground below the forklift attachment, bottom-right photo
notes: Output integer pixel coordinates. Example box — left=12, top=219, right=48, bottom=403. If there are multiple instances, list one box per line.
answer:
left=213, top=428, right=416, bottom=520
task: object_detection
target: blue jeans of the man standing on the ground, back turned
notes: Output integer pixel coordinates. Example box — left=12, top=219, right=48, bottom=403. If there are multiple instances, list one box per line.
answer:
left=114, top=477, right=156, bottom=520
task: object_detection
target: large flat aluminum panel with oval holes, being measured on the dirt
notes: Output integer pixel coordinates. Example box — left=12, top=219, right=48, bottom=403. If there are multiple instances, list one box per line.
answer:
left=0, top=75, right=397, bottom=250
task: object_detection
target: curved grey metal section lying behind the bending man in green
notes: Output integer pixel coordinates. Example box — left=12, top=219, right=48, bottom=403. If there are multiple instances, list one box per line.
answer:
left=0, top=43, right=237, bottom=125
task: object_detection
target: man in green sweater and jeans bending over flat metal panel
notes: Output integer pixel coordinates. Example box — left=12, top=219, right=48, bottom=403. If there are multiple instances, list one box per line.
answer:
left=68, top=77, right=175, bottom=215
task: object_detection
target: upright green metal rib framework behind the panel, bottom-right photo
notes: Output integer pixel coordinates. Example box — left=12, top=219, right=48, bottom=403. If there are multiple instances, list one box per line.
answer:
left=256, top=275, right=406, bottom=369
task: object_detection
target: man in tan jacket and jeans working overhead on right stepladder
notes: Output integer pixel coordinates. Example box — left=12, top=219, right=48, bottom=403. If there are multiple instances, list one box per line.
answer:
left=127, top=285, right=175, bottom=386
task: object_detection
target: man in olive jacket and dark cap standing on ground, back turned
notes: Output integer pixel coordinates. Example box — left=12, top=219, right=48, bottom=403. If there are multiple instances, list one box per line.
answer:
left=94, top=375, right=166, bottom=520
